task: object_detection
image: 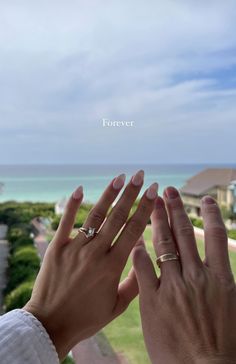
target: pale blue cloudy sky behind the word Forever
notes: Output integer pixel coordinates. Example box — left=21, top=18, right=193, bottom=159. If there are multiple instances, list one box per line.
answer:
left=0, top=0, right=236, bottom=164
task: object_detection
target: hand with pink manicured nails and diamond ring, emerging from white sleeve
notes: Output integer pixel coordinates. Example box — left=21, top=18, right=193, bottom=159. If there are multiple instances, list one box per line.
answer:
left=24, top=171, right=157, bottom=359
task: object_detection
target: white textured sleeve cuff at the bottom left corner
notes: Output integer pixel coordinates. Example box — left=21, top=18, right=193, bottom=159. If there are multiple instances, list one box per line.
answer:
left=0, top=309, right=59, bottom=364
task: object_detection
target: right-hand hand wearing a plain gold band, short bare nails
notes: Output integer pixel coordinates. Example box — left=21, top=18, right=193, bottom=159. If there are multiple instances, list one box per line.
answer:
left=133, top=187, right=236, bottom=364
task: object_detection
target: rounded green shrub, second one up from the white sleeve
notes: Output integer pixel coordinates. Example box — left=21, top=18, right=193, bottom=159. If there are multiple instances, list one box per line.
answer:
left=6, top=246, right=40, bottom=292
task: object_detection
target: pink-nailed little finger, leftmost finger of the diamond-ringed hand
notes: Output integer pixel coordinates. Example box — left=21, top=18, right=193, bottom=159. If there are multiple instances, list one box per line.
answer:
left=54, top=186, right=83, bottom=244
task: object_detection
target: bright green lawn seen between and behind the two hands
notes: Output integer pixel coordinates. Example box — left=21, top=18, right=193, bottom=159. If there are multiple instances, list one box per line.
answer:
left=103, top=228, right=236, bottom=364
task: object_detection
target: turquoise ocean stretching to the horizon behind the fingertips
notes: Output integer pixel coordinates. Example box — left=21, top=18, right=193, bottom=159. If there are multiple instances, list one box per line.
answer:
left=0, top=164, right=235, bottom=203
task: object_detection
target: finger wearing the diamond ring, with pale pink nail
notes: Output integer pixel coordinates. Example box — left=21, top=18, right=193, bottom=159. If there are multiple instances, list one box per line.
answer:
left=75, top=174, right=125, bottom=244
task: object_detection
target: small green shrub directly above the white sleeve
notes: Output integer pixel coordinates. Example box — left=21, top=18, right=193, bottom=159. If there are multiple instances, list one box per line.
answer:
left=4, top=281, right=34, bottom=312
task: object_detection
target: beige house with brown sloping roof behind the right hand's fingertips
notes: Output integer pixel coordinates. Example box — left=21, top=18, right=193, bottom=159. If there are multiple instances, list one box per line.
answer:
left=180, top=168, right=236, bottom=216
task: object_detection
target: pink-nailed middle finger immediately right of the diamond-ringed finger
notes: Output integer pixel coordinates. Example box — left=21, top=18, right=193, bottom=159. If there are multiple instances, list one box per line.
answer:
left=99, top=170, right=144, bottom=250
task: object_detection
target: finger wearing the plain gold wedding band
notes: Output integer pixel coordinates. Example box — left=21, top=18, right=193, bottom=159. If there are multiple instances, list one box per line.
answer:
left=151, top=197, right=181, bottom=277
